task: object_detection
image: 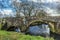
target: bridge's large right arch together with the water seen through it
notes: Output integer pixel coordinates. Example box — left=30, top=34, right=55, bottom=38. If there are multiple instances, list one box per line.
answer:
left=26, top=20, right=53, bottom=36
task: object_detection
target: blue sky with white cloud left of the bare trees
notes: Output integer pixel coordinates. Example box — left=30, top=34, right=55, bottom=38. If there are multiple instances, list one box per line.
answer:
left=0, top=0, right=15, bottom=16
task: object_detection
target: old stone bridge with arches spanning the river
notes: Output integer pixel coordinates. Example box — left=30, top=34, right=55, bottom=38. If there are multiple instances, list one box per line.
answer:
left=1, top=17, right=60, bottom=34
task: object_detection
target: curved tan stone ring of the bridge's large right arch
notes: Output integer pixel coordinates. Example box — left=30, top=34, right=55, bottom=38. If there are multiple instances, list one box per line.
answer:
left=27, top=20, right=55, bottom=32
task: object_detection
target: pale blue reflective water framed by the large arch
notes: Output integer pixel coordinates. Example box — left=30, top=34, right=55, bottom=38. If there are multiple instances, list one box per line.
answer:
left=28, top=24, right=50, bottom=36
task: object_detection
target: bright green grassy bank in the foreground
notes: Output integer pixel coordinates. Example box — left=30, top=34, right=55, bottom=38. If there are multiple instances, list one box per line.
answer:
left=0, top=31, right=53, bottom=40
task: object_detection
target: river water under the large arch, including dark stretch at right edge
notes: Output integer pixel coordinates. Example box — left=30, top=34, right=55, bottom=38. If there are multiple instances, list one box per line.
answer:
left=27, top=24, right=60, bottom=40
